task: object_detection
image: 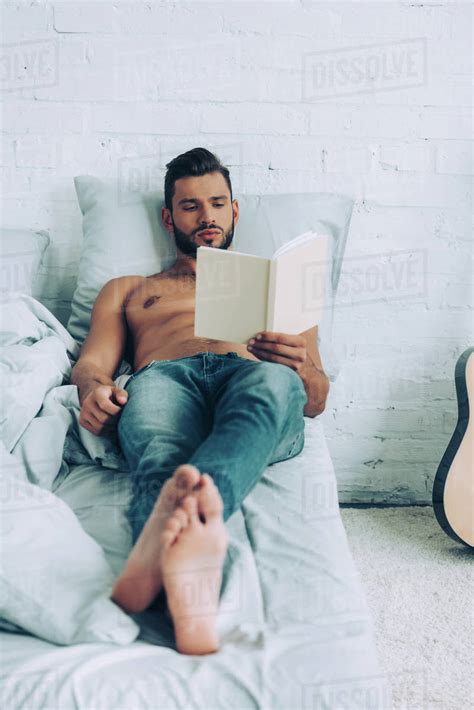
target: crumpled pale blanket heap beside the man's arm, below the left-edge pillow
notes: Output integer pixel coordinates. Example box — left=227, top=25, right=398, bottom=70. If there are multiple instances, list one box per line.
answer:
left=0, top=292, right=128, bottom=490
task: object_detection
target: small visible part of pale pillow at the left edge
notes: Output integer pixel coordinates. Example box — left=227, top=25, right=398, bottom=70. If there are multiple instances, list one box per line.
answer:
left=0, top=229, right=51, bottom=297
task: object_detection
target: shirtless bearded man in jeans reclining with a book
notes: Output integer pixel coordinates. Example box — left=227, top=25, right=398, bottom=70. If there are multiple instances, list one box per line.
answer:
left=71, top=148, right=329, bottom=654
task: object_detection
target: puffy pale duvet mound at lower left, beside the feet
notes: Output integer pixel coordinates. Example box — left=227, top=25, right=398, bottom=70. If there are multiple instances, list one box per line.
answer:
left=0, top=440, right=139, bottom=644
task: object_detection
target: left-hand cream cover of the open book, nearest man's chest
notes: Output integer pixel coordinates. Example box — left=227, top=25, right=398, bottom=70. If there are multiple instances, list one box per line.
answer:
left=194, top=247, right=270, bottom=343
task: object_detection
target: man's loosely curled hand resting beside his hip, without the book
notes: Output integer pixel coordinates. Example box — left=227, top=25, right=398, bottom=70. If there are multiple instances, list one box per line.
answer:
left=79, top=385, right=128, bottom=436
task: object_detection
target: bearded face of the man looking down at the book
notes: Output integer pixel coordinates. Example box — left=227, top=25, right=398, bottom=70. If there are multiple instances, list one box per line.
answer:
left=163, top=173, right=238, bottom=257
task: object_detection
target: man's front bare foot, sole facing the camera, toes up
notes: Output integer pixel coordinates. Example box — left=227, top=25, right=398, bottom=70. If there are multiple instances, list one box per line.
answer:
left=160, top=484, right=228, bottom=655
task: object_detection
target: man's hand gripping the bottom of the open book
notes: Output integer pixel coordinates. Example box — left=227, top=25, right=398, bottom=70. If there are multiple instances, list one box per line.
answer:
left=247, top=330, right=307, bottom=374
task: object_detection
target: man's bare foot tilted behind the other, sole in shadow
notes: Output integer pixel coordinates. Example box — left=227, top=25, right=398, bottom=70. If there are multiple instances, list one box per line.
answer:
left=112, top=464, right=202, bottom=614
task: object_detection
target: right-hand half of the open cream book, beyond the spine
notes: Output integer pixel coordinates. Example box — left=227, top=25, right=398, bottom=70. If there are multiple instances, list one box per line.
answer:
left=268, top=234, right=329, bottom=335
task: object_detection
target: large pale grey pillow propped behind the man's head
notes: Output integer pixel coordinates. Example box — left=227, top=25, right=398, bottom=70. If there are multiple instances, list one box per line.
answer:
left=67, top=175, right=354, bottom=379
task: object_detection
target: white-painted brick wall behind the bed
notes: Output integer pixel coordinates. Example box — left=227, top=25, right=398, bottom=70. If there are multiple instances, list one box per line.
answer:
left=0, top=0, right=473, bottom=503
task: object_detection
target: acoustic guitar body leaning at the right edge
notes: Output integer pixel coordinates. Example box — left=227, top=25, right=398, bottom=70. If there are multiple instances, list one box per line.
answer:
left=433, top=348, right=474, bottom=547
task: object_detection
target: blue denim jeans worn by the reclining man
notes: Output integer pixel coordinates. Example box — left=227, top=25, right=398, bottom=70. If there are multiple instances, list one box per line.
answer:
left=117, top=352, right=307, bottom=541
